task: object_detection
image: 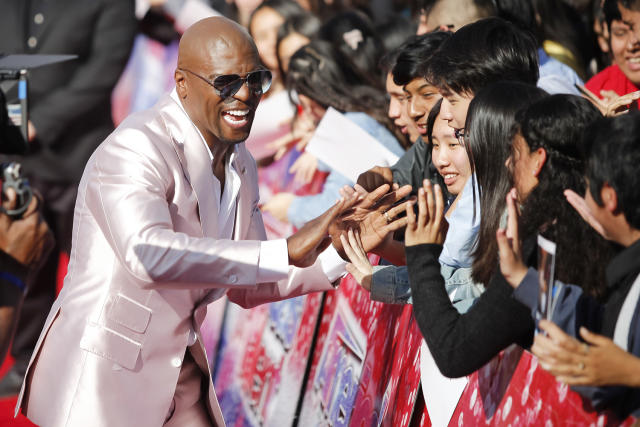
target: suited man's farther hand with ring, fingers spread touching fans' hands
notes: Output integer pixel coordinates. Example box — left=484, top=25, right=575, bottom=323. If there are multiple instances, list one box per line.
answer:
left=329, top=184, right=411, bottom=259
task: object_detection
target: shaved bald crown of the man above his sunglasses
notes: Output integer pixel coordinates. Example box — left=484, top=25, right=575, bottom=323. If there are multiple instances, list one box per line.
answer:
left=178, top=16, right=258, bottom=69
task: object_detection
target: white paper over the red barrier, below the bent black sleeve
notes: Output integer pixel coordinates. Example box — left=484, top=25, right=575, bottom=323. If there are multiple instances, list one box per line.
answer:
left=420, top=340, right=468, bottom=427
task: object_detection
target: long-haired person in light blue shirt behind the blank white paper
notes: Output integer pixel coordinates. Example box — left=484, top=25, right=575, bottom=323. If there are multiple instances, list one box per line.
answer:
left=263, top=40, right=404, bottom=231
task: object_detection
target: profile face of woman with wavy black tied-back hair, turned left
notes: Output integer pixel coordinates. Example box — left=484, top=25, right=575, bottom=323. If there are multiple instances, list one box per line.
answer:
left=506, top=133, right=542, bottom=203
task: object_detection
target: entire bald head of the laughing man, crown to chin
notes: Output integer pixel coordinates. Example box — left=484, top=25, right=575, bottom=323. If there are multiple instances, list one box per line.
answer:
left=174, top=17, right=264, bottom=152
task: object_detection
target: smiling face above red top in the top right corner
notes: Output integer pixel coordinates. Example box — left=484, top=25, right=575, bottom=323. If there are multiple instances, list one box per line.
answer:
left=610, top=3, right=640, bottom=85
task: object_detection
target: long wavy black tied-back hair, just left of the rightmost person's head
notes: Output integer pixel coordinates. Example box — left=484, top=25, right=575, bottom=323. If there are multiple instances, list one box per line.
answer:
left=514, top=95, right=611, bottom=297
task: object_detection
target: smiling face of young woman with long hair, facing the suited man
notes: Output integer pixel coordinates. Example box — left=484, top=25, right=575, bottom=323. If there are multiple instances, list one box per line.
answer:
left=431, top=116, right=471, bottom=195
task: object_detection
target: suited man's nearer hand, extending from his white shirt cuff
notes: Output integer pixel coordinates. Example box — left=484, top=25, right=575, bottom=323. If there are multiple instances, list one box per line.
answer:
left=287, top=194, right=359, bottom=267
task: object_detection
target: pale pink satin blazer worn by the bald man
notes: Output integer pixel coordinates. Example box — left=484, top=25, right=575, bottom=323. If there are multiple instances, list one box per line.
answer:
left=16, top=95, right=332, bottom=427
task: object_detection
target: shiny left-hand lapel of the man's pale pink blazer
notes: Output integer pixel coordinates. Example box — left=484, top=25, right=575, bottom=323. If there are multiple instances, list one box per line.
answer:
left=159, top=95, right=220, bottom=237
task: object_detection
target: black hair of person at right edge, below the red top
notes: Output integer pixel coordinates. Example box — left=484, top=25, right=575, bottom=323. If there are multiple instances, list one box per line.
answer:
left=584, top=111, right=640, bottom=230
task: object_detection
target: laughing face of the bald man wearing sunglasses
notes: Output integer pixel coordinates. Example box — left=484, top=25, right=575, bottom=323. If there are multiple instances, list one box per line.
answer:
left=176, top=40, right=264, bottom=146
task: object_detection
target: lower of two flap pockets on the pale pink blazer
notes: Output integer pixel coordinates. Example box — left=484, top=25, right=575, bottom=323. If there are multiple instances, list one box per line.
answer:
left=80, top=323, right=142, bottom=369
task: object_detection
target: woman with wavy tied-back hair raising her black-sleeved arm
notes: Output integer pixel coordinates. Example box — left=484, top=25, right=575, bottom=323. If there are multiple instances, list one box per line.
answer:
left=405, top=95, right=608, bottom=377
